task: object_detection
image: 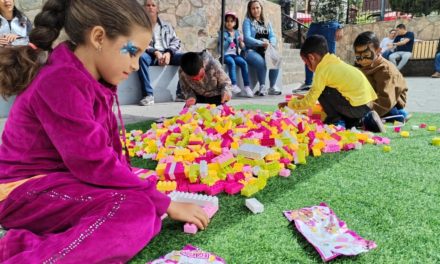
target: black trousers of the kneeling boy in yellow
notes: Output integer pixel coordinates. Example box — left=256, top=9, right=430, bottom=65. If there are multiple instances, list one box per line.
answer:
left=318, top=87, right=371, bottom=127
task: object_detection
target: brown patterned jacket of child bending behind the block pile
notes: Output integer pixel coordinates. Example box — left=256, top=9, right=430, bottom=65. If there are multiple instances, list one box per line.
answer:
left=179, top=51, right=232, bottom=99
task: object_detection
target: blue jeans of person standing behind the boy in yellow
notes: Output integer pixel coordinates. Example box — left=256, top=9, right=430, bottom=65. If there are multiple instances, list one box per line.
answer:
left=304, top=22, right=339, bottom=85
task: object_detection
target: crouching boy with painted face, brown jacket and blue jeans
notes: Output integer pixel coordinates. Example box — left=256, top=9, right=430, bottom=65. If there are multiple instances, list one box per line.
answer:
left=353, top=31, right=408, bottom=122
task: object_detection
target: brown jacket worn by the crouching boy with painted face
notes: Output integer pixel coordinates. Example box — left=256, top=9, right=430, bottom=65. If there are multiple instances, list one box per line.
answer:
left=360, top=57, right=408, bottom=116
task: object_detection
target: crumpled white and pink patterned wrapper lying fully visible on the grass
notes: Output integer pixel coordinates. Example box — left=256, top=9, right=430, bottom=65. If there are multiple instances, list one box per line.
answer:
left=284, top=203, right=376, bottom=261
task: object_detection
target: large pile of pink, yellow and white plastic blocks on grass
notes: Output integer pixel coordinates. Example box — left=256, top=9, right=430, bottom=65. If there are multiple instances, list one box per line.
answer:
left=123, top=105, right=389, bottom=197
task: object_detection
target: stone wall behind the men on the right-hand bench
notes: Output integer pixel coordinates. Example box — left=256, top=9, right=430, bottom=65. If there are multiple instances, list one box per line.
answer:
left=336, top=16, right=440, bottom=63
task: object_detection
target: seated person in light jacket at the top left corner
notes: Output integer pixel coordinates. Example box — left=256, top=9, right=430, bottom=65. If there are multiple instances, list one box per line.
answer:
left=0, top=1, right=32, bottom=47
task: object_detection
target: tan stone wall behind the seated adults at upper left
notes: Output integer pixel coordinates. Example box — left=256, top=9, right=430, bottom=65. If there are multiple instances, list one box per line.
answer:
left=16, top=0, right=282, bottom=55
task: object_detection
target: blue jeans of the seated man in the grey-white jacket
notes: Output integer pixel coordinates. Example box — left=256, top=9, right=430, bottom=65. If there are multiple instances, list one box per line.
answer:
left=138, top=52, right=183, bottom=97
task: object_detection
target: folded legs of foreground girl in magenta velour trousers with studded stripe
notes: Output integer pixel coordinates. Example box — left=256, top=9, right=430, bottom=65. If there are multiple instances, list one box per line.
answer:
left=0, top=173, right=161, bottom=264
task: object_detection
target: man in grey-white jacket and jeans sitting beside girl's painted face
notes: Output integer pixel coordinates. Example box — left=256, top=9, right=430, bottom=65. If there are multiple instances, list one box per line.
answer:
left=138, top=0, right=183, bottom=105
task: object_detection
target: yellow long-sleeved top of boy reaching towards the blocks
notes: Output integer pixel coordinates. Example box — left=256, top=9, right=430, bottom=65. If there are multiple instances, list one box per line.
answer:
left=288, top=53, right=377, bottom=110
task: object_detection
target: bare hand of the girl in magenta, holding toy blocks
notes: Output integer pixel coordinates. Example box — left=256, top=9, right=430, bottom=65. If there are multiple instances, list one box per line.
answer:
left=167, top=201, right=209, bottom=230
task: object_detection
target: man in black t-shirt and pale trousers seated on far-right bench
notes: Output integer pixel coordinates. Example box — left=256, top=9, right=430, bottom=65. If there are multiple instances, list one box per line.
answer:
left=389, top=24, right=414, bottom=71
